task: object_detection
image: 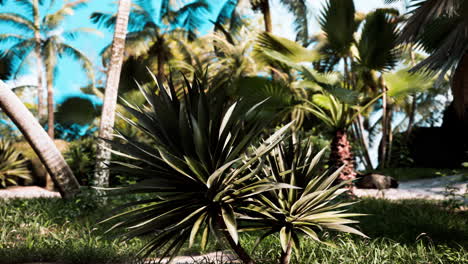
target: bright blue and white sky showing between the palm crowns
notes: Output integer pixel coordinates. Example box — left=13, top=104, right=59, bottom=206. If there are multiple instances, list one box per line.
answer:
left=0, top=0, right=402, bottom=102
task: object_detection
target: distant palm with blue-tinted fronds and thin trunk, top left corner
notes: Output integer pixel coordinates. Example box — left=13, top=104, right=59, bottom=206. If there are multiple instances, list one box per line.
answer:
left=0, top=0, right=94, bottom=138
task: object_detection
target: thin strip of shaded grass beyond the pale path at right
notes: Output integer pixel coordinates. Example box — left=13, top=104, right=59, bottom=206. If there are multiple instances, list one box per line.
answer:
left=366, top=168, right=468, bottom=181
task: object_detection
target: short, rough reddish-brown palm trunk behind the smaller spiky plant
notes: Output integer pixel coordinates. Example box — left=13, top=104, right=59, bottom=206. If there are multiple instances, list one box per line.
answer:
left=329, top=129, right=356, bottom=182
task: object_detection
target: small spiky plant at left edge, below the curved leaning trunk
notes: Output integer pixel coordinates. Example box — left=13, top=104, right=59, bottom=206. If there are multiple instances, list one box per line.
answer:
left=0, top=139, right=31, bottom=187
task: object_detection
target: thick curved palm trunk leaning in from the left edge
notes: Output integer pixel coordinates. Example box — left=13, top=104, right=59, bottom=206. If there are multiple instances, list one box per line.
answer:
left=0, top=81, right=80, bottom=198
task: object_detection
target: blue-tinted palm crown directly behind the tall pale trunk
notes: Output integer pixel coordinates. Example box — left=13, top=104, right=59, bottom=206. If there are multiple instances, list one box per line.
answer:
left=91, top=0, right=209, bottom=80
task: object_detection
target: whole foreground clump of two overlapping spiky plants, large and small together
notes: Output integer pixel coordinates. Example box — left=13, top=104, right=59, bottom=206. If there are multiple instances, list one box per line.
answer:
left=102, top=75, right=366, bottom=263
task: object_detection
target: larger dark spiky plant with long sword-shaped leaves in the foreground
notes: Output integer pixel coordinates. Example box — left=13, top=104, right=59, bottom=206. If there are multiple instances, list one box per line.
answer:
left=102, top=75, right=289, bottom=263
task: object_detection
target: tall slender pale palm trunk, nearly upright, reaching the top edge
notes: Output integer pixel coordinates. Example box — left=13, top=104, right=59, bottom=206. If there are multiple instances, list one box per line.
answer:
left=94, top=0, right=131, bottom=187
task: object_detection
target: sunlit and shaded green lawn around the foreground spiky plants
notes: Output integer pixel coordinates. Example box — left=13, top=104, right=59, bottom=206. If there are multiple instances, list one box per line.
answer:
left=0, top=193, right=468, bottom=264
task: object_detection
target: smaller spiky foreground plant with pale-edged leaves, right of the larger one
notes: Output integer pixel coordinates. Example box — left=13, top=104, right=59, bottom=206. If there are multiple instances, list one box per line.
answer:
left=240, top=137, right=366, bottom=264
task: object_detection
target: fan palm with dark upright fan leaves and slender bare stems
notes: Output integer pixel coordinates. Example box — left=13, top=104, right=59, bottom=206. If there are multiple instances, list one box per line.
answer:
left=315, top=0, right=400, bottom=167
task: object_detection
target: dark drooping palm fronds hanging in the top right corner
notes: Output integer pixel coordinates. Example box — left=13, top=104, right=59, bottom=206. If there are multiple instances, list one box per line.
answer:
left=386, top=0, right=468, bottom=149
